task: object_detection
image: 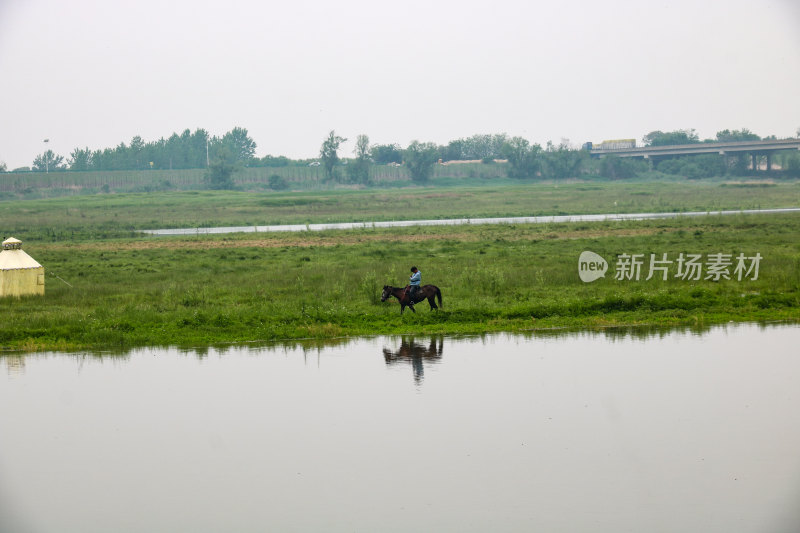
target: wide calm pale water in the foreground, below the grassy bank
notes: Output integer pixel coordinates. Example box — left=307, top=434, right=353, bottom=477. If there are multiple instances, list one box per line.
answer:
left=0, top=325, right=800, bottom=533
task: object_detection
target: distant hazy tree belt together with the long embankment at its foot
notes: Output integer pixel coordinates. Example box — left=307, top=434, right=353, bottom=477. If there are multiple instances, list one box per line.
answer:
left=6, top=127, right=800, bottom=195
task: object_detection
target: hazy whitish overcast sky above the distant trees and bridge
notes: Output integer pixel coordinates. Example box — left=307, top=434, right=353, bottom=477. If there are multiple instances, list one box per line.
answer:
left=0, top=0, right=800, bottom=169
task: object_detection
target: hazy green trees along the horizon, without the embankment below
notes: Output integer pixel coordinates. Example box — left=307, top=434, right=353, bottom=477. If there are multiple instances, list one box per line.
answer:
left=7, top=127, right=800, bottom=184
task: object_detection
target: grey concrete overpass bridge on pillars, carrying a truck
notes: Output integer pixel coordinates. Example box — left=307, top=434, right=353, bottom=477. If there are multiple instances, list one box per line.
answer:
left=589, top=139, right=800, bottom=170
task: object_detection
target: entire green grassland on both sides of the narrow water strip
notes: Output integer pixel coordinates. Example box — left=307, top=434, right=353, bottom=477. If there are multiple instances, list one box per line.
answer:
left=0, top=183, right=800, bottom=350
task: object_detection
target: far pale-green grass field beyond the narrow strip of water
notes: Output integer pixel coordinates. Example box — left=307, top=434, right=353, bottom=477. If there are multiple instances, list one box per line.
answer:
left=0, top=181, right=800, bottom=242
